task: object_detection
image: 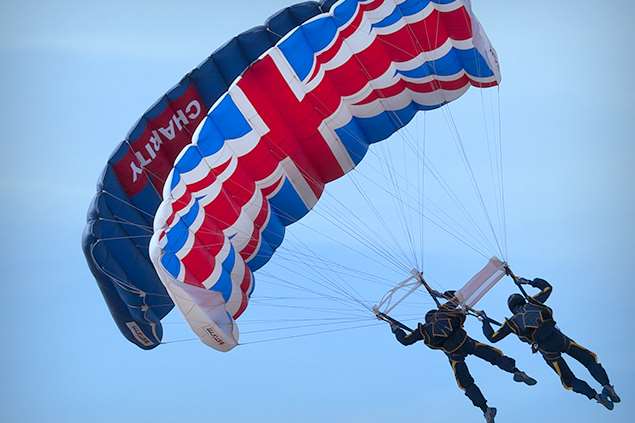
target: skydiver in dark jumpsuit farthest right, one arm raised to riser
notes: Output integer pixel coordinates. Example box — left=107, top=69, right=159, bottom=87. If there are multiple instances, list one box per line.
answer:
left=481, top=278, right=620, bottom=410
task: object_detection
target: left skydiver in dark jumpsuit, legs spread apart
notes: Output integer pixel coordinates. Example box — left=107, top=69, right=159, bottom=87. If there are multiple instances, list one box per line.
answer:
left=391, top=291, right=536, bottom=423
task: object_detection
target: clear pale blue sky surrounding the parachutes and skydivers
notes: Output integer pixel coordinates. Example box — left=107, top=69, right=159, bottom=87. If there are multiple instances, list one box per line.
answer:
left=0, top=0, right=635, bottom=423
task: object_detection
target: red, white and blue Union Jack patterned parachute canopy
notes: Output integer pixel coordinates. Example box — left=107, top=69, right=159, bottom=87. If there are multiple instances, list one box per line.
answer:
left=150, top=0, right=500, bottom=351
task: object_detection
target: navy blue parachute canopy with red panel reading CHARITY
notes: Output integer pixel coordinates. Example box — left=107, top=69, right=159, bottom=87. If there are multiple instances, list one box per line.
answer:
left=82, top=0, right=346, bottom=349
